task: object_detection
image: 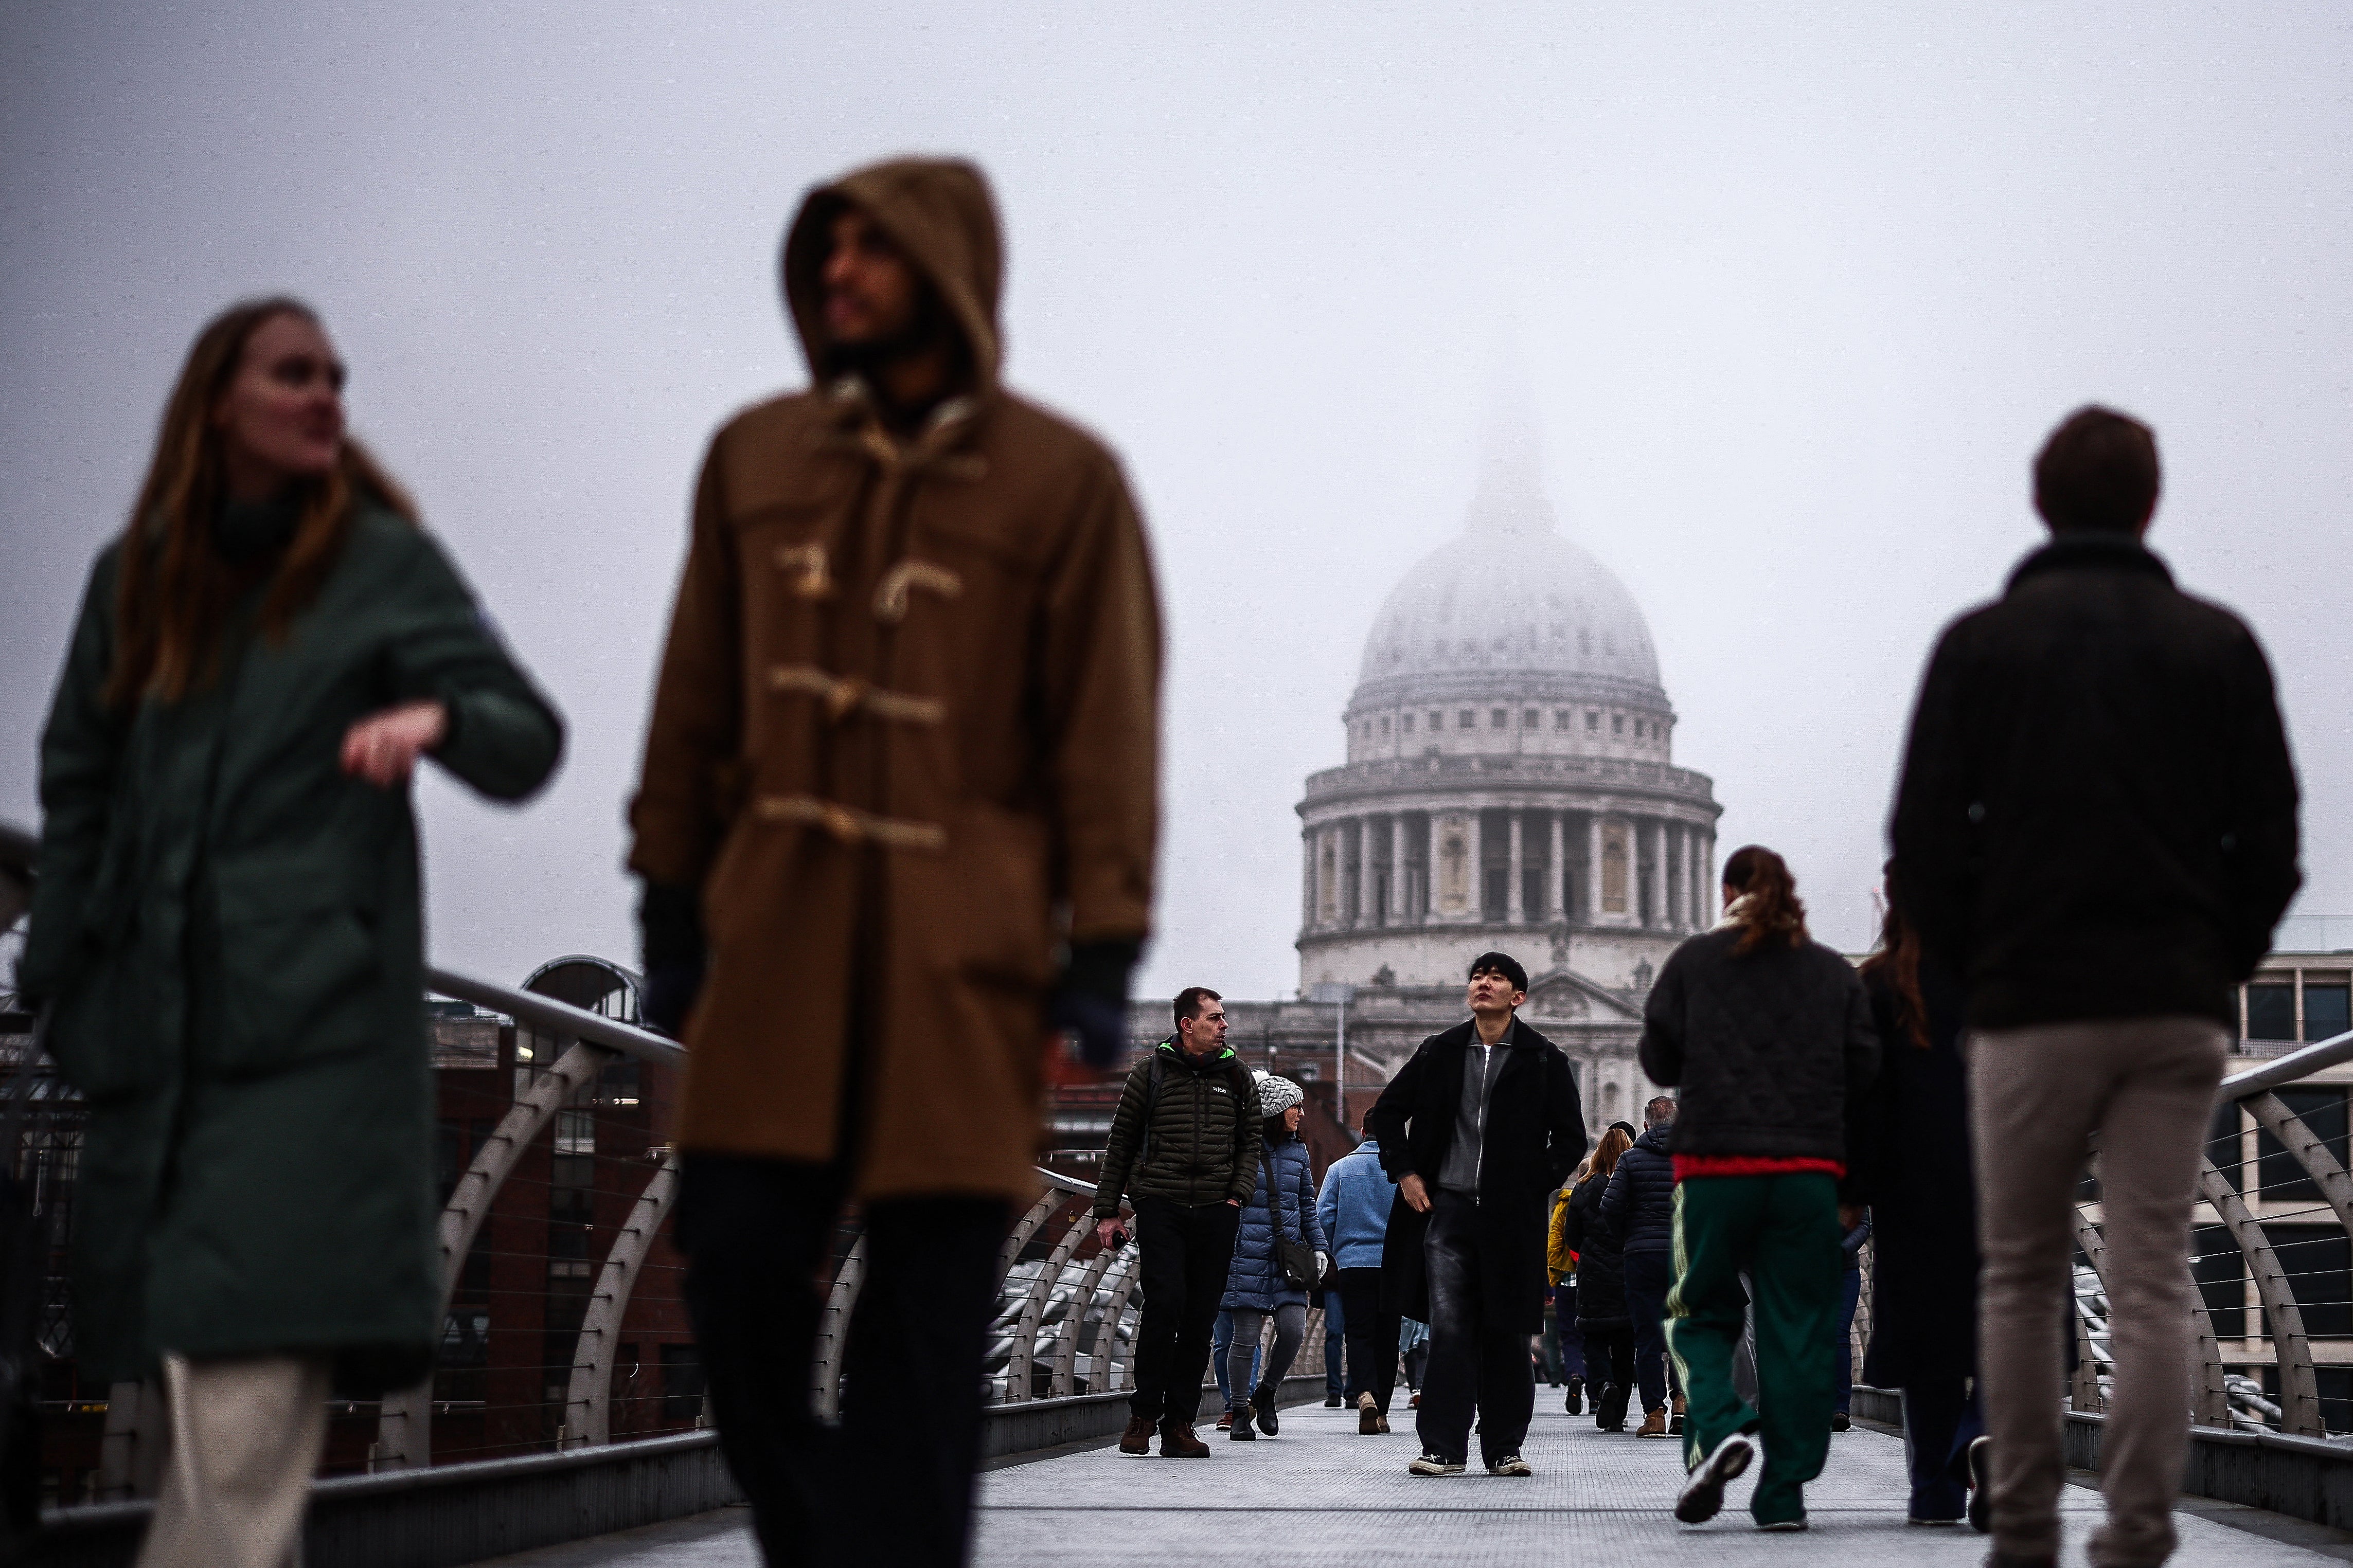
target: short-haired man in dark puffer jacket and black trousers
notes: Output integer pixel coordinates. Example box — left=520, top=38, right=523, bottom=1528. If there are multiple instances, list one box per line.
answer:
left=1094, top=985, right=1261, bottom=1460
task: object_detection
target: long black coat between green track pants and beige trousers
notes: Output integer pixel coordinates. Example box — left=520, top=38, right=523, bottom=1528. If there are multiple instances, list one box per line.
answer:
left=1852, top=957, right=1976, bottom=1387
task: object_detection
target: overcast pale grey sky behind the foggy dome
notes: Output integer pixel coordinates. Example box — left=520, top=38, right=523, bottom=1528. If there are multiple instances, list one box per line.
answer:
left=0, top=0, right=2353, bottom=997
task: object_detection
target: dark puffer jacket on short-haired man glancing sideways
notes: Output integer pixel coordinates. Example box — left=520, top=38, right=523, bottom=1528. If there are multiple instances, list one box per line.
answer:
left=1094, top=1039, right=1263, bottom=1218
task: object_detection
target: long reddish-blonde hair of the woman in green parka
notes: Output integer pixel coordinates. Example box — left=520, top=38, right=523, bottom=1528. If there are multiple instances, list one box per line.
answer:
left=106, top=294, right=417, bottom=708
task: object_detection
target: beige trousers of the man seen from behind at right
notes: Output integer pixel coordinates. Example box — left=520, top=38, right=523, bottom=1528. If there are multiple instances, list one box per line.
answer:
left=1965, top=1018, right=2231, bottom=1568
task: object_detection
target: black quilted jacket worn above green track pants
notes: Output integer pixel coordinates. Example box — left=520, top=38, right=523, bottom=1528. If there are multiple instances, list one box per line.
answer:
left=1643, top=926, right=1880, bottom=1164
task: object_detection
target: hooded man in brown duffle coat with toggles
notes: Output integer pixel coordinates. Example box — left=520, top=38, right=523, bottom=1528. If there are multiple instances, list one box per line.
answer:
left=628, top=160, right=1160, bottom=1563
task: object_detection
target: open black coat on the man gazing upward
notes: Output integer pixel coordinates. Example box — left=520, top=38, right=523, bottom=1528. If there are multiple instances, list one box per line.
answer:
left=1367, top=1020, right=1586, bottom=1333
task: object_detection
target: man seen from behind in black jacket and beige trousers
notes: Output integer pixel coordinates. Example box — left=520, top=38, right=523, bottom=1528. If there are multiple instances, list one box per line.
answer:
left=1892, top=409, right=2299, bottom=1565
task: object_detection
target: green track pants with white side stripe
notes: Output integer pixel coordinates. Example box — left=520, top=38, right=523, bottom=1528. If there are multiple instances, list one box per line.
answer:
left=1666, top=1170, right=1845, bottom=1523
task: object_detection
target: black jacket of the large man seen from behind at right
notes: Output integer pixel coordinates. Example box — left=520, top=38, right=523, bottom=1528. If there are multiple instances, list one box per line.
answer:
left=1892, top=534, right=2301, bottom=1030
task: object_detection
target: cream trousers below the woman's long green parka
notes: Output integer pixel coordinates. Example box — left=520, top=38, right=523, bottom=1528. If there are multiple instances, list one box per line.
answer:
left=139, top=1354, right=329, bottom=1568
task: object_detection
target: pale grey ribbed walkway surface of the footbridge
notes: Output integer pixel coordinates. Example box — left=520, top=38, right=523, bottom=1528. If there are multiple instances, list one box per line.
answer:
left=482, top=1390, right=2353, bottom=1568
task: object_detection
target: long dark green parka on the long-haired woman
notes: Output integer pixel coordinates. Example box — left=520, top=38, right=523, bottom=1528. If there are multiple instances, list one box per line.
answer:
left=19, top=508, right=562, bottom=1387
